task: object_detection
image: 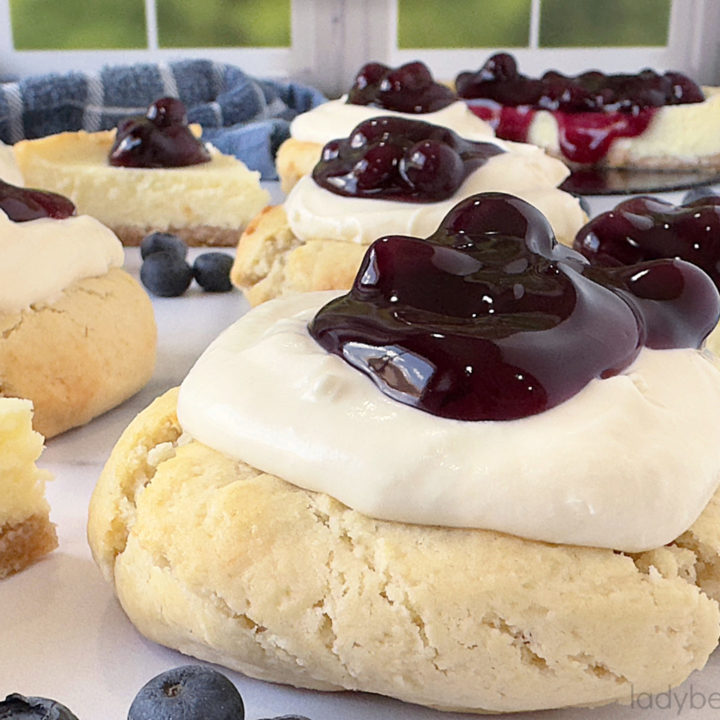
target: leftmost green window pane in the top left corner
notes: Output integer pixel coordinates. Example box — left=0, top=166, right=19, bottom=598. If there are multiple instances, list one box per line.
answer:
left=10, top=0, right=147, bottom=50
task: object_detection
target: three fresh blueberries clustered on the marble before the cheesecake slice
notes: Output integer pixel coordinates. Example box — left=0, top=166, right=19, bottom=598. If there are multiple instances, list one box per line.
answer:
left=140, top=232, right=233, bottom=297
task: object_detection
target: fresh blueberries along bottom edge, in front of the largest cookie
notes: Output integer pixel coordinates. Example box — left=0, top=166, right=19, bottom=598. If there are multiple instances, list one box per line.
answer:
left=0, top=665, right=309, bottom=720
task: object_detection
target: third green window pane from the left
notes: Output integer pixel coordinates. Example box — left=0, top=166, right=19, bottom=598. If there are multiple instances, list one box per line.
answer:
left=398, top=0, right=530, bottom=49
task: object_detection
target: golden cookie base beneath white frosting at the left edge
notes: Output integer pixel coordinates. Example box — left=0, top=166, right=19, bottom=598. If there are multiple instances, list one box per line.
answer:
left=0, top=268, right=157, bottom=437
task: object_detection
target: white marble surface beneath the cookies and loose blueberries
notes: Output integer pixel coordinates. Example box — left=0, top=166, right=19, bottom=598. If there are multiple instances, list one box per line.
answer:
left=0, top=183, right=720, bottom=720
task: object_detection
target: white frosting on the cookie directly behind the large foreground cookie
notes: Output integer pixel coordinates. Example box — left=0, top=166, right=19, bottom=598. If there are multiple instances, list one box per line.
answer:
left=284, top=141, right=587, bottom=245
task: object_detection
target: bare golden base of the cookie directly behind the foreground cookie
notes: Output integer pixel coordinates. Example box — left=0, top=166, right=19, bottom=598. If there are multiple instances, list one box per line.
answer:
left=230, top=205, right=367, bottom=305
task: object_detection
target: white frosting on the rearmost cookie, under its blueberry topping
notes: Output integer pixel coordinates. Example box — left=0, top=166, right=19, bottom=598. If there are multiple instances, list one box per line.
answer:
left=290, top=95, right=495, bottom=145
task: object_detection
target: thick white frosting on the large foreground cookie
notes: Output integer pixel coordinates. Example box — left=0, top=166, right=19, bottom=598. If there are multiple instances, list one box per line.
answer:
left=178, top=292, right=720, bottom=552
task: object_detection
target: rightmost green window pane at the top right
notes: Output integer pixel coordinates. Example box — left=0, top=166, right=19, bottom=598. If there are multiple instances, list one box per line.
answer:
left=540, top=0, right=671, bottom=47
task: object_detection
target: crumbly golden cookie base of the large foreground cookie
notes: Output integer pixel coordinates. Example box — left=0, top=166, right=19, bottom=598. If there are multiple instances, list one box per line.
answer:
left=88, top=391, right=720, bottom=712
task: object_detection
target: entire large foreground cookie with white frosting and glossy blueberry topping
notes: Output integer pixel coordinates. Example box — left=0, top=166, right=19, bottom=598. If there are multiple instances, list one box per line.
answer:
left=93, top=193, right=720, bottom=712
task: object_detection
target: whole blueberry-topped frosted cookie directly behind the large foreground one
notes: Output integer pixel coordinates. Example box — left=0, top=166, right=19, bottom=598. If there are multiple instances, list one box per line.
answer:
left=231, top=116, right=587, bottom=305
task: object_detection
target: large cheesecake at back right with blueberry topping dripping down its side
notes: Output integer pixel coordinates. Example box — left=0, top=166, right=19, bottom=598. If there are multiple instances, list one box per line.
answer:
left=455, top=53, right=720, bottom=170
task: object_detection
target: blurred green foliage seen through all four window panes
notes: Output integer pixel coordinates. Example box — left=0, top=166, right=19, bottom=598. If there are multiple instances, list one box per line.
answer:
left=10, top=0, right=671, bottom=50
